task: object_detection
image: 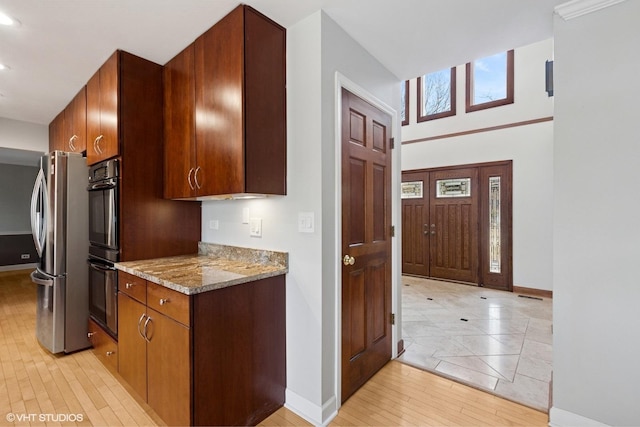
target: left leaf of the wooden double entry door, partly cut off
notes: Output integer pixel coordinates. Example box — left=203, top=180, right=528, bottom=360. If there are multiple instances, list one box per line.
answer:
left=402, top=171, right=431, bottom=276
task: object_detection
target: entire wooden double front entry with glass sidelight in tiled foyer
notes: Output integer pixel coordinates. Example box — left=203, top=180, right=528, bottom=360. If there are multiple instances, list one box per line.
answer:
left=402, top=161, right=513, bottom=291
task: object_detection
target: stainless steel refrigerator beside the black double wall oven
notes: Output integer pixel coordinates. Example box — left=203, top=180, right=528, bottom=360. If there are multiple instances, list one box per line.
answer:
left=31, top=151, right=90, bottom=353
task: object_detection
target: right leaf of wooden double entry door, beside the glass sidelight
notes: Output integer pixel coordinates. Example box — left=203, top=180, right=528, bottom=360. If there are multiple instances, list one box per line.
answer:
left=429, top=168, right=478, bottom=283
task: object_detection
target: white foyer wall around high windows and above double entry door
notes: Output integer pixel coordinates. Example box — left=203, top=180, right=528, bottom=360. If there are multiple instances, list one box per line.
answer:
left=402, top=39, right=554, bottom=290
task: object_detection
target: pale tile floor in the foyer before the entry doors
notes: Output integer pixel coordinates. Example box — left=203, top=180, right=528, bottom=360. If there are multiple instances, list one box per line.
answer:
left=398, top=276, right=553, bottom=412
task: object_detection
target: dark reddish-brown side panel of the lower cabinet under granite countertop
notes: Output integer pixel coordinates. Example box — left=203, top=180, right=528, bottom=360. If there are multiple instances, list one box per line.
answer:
left=193, top=276, right=286, bottom=425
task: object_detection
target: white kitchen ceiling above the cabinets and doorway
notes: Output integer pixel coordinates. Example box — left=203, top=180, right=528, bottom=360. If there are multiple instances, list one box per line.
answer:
left=0, top=0, right=565, bottom=124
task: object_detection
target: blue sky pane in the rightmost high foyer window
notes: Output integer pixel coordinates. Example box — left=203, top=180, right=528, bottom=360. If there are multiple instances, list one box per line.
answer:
left=473, top=52, right=507, bottom=105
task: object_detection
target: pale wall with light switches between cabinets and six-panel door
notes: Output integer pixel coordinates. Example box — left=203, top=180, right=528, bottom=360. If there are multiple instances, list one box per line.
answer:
left=202, top=12, right=400, bottom=424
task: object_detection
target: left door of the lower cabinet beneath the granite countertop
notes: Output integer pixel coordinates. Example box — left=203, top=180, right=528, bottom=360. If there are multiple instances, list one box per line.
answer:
left=118, top=292, right=148, bottom=401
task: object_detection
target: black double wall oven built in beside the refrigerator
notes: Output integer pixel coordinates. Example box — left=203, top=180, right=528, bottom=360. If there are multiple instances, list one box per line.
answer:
left=87, top=159, right=120, bottom=338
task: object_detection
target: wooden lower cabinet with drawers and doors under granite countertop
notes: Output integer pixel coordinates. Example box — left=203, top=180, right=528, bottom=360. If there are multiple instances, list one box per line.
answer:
left=118, top=272, right=286, bottom=426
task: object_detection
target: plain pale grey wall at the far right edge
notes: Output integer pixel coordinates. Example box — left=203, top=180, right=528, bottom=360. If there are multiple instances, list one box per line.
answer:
left=550, top=1, right=640, bottom=426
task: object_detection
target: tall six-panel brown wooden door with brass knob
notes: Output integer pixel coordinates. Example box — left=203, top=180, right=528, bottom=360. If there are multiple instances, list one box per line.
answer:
left=341, top=89, right=391, bottom=402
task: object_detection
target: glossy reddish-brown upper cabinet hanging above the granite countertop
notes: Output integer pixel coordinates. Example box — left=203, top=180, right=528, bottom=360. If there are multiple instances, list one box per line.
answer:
left=164, top=5, right=287, bottom=199
